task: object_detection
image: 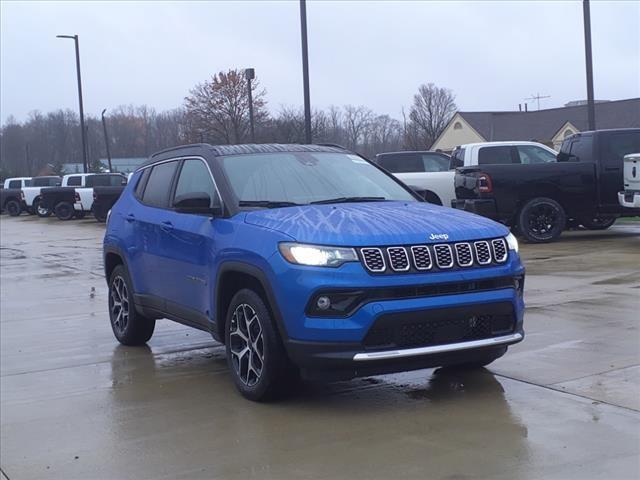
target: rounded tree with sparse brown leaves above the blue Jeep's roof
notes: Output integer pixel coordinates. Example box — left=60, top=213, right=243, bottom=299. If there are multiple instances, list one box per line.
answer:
left=185, top=70, right=268, bottom=143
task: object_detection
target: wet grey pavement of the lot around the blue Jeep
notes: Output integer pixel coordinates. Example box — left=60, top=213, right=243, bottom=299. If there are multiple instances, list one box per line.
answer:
left=0, top=215, right=640, bottom=480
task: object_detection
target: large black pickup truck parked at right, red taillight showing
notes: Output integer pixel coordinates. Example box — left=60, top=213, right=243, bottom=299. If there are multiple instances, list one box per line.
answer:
left=453, top=128, right=640, bottom=243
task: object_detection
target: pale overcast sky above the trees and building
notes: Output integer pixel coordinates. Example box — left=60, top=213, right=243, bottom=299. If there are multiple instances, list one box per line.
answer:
left=0, top=0, right=640, bottom=122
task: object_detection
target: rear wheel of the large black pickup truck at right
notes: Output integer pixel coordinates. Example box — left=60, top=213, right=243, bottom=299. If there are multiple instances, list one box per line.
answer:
left=517, top=197, right=567, bottom=243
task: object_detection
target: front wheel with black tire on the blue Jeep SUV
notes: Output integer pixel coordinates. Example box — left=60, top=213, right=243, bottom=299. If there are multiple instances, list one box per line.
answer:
left=225, top=289, right=292, bottom=402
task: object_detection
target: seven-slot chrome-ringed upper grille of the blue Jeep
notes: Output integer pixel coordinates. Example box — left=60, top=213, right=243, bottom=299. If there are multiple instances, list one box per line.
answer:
left=360, top=238, right=509, bottom=274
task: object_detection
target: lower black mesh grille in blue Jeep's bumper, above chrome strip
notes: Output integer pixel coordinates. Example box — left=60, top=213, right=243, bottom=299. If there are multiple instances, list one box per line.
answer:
left=364, top=304, right=515, bottom=349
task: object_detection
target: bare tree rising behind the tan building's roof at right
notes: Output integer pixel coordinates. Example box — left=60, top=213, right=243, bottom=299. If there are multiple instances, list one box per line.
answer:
left=405, top=83, right=457, bottom=149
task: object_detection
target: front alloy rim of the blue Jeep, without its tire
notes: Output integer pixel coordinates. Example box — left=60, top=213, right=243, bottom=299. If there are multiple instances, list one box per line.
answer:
left=229, top=303, right=264, bottom=387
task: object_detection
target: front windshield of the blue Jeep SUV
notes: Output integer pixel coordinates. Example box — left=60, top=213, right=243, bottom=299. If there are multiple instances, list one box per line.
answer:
left=221, top=152, right=415, bottom=206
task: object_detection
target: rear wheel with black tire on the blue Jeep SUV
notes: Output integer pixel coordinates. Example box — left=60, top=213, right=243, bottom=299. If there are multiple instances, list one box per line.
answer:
left=109, top=265, right=156, bottom=346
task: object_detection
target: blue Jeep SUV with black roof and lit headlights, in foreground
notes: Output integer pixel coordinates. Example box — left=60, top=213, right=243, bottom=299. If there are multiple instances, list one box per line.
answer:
left=104, top=144, right=524, bottom=400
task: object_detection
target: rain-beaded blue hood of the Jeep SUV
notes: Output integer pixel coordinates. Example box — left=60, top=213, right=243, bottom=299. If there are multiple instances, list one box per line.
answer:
left=245, top=202, right=509, bottom=246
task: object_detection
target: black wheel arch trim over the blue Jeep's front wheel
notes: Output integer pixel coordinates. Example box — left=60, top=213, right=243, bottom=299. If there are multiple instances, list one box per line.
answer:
left=211, top=261, right=287, bottom=343
